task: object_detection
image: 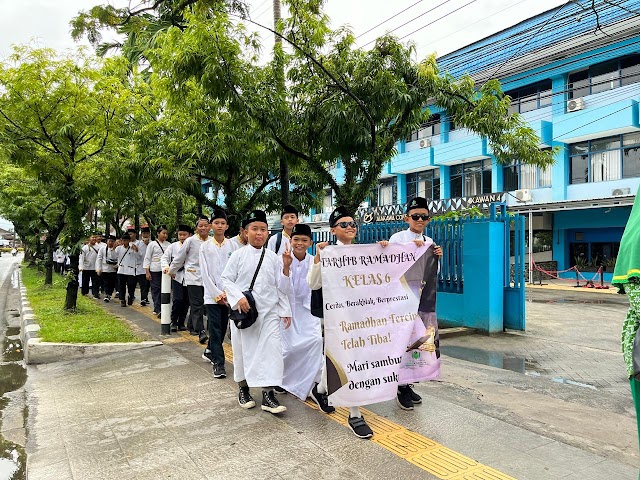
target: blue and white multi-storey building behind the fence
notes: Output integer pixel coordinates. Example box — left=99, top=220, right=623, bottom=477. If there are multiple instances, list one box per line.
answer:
left=312, top=0, right=640, bottom=279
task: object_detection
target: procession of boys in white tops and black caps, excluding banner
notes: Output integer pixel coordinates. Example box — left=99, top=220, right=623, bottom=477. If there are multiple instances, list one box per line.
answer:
left=81, top=198, right=442, bottom=438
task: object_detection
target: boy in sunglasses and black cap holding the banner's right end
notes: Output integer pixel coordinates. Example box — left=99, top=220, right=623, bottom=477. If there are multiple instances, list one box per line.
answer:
left=379, top=197, right=442, bottom=410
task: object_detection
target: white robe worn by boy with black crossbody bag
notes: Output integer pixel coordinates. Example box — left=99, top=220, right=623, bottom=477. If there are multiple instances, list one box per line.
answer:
left=221, top=245, right=291, bottom=387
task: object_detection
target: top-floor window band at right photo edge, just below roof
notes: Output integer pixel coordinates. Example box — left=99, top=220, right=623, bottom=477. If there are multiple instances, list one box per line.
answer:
left=569, top=55, right=640, bottom=98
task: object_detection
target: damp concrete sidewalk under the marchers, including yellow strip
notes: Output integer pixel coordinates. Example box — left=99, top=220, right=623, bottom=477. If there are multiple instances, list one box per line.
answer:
left=26, top=290, right=637, bottom=480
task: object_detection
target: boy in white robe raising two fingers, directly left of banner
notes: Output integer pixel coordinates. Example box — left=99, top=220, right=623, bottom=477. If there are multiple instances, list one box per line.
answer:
left=280, top=223, right=335, bottom=413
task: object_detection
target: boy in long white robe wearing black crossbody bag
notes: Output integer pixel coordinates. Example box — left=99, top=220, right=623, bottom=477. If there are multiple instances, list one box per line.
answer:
left=222, top=210, right=292, bottom=414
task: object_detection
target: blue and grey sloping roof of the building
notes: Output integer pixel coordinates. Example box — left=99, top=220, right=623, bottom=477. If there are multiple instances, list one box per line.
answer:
left=438, top=0, right=640, bottom=81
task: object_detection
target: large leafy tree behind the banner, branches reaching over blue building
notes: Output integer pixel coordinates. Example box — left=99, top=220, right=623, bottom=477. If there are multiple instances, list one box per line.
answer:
left=75, top=0, right=554, bottom=214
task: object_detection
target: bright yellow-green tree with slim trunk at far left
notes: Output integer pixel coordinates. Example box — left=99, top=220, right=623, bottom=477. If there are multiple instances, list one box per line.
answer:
left=0, top=47, right=128, bottom=310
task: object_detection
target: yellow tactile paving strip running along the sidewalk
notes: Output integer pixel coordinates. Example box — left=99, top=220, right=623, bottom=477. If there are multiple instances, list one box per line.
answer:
left=126, top=305, right=516, bottom=480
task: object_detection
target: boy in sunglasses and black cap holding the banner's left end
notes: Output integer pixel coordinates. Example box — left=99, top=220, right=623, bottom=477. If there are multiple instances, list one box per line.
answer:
left=307, top=207, right=373, bottom=439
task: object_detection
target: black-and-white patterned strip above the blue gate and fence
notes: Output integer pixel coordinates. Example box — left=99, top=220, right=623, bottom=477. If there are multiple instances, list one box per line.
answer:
left=357, top=192, right=507, bottom=224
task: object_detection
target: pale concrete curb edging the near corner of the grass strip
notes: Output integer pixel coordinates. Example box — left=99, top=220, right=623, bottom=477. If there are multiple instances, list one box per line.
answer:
left=18, top=267, right=163, bottom=365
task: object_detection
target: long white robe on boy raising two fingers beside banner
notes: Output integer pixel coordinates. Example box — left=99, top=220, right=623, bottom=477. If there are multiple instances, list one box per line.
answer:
left=281, top=253, right=324, bottom=401
